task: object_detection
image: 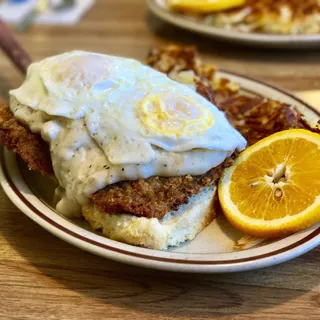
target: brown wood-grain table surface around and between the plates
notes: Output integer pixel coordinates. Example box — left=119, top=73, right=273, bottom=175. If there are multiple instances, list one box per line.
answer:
left=0, top=0, right=320, bottom=320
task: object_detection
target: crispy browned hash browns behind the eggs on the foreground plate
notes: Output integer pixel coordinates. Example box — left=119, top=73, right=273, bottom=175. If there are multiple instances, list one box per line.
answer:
left=147, top=45, right=320, bottom=145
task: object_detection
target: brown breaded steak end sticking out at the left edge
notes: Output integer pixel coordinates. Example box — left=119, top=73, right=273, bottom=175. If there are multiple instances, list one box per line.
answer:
left=0, top=105, right=53, bottom=174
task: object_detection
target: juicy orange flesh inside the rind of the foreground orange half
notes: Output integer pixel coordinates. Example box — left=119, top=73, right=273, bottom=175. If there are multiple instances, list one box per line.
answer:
left=230, top=138, right=320, bottom=220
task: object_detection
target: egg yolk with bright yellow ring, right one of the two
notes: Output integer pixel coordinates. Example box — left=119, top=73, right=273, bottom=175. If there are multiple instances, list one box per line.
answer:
left=139, top=95, right=214, bottom=137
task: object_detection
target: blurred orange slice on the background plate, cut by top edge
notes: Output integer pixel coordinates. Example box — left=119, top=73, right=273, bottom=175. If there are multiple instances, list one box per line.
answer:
left=168, top=0, right=246, bottom=13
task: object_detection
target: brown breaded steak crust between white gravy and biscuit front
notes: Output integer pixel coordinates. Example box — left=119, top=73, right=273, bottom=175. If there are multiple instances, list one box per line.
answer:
left=91, top=158, right=233, bottom=219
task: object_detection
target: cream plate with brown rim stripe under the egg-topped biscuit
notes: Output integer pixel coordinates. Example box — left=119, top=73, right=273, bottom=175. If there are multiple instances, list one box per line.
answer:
left=0, top=72, right=320, bottom=273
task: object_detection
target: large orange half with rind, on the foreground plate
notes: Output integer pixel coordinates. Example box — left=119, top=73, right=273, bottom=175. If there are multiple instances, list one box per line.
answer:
left=218, top=129, right=320, bottom=238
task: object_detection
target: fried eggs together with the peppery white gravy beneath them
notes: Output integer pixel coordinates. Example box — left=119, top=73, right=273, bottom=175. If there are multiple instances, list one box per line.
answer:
left=10, top=51, right=246, bottom=214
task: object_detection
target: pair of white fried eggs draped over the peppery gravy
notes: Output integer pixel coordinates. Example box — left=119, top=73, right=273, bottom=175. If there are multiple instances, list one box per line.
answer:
left=11, top=51, right=245, bottom=164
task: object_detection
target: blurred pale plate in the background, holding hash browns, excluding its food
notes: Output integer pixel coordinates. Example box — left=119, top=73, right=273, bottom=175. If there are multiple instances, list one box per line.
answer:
left=148, top=0, right=320, bottom=48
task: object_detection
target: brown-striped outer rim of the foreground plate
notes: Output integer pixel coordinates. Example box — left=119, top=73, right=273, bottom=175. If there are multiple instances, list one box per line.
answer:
left=0, top=69, right=320, bottom=273
